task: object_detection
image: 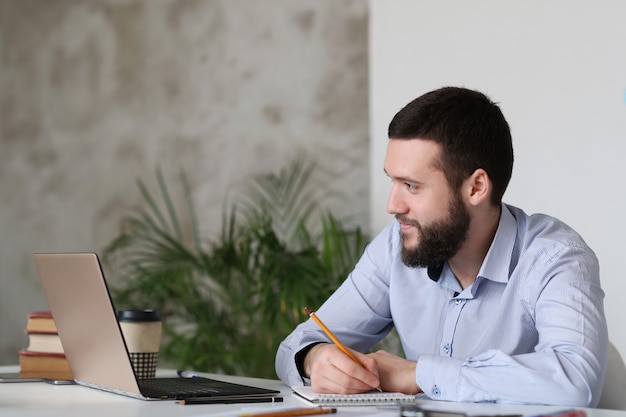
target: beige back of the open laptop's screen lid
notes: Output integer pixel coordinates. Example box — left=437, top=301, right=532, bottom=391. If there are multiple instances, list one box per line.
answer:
left=34, top=253, right=141, bottom=395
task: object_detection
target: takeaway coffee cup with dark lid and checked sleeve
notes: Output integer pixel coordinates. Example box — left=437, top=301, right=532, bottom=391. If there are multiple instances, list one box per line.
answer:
left=117, top=310, right=162, bottom=379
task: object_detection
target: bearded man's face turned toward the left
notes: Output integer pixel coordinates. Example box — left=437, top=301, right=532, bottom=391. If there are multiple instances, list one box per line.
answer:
left=385, top=139, right=470, bottom=267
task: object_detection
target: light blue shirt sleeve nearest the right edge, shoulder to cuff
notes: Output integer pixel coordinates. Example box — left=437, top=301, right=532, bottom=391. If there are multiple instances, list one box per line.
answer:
left=416, top=247, right=608, bottom=407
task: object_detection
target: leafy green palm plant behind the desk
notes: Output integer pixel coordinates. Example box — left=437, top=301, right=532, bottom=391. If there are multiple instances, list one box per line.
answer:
left=104, top=158, right=366, bottom=378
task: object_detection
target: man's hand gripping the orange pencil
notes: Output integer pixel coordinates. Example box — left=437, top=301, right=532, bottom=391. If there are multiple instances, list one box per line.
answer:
left=304, top=343, right=380, bottom=394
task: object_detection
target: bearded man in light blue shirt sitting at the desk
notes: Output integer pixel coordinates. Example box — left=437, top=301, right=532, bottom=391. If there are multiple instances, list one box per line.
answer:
left=276, top=87, right=608, bottom=406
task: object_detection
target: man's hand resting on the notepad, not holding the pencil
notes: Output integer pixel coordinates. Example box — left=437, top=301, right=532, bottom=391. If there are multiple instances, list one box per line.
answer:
left=367, top=350, right=422, bottom=394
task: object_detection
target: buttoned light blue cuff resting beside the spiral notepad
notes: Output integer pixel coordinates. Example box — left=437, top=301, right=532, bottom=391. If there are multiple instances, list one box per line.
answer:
left=415, top=355, right=465, bottom=401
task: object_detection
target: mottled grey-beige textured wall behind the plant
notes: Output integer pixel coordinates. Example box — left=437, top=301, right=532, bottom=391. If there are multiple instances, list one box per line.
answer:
left=0, top=0, right=369, bottom=364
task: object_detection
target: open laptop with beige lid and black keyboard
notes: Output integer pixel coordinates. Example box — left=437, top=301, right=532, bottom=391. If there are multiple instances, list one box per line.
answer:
left=34, top=253, right=279, bottom=401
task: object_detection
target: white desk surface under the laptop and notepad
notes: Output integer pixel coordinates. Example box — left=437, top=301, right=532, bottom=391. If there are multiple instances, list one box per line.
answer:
left=0, top=366, right=626, bottom=417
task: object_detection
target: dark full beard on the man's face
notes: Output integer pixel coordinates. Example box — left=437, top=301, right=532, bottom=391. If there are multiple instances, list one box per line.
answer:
left=396, top=195, right=470, bottom=267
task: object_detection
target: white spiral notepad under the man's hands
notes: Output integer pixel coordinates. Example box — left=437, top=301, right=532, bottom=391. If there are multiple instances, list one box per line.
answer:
left=291, top=386, right=417, bottom=407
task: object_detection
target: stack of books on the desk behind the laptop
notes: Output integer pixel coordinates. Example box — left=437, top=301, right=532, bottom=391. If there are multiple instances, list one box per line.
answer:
left=19, top=311, right=73, bottom=379
